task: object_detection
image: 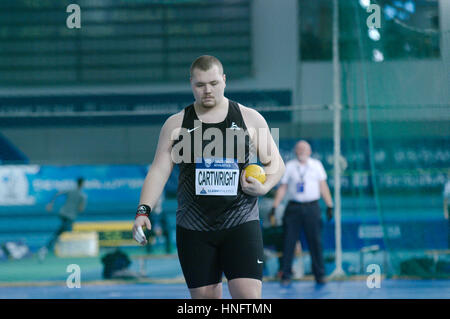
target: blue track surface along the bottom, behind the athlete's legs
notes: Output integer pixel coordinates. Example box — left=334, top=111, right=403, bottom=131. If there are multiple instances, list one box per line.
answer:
left=0, top=280, right=450, bottom=299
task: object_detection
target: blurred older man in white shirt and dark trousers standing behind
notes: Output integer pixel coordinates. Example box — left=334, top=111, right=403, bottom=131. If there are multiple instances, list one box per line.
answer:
left=272, top=140, right=333, bottom=285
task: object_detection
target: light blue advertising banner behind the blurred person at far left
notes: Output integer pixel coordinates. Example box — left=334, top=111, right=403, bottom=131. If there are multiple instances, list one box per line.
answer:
left=0, top=165, right=148, bottom=212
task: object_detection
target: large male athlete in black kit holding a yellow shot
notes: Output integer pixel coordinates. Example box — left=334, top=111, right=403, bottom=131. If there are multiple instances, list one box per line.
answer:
left=133, top=56, right=284, bottom=298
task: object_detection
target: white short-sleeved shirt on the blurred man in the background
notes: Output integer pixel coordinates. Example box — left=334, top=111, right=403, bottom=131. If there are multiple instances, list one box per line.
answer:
left=281, top=158, right=327, bottom=202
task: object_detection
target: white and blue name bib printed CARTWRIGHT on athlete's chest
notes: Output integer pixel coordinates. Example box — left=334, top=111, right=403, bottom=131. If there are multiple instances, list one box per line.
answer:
left=195, top=158, right=239, bottom=196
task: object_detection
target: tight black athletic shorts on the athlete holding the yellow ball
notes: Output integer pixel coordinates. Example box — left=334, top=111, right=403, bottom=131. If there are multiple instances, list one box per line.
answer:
left=177, top=220, right=264, bottom=288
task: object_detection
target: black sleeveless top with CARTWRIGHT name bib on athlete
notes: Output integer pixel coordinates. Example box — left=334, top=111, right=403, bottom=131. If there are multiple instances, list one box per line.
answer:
left=173, top=100, right=259, bottom=231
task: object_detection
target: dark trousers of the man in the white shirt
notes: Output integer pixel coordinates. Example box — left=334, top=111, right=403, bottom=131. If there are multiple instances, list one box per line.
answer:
left=282, top=201, right=325, bottom=280
